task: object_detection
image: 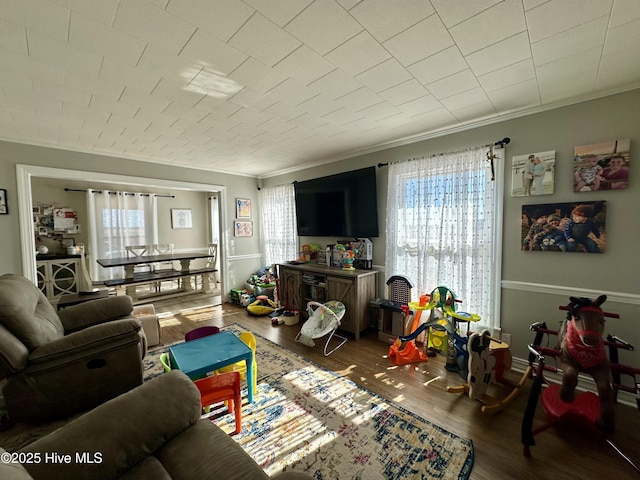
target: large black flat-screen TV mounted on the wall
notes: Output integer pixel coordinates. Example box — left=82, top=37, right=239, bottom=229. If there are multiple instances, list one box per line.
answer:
left=294, top=167, right=378, bottom=238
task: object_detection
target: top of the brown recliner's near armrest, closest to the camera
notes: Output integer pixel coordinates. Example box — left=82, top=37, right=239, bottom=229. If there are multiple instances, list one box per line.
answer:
left=29, top=318, right=142, bottom=368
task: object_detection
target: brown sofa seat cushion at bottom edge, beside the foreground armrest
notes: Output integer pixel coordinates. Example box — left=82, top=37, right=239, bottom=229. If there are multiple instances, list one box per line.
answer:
left=156, top=419, right=269, bottom=480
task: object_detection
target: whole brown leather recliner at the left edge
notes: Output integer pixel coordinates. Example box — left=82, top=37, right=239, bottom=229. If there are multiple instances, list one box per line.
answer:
left=0, top=274, right=146, bottom=423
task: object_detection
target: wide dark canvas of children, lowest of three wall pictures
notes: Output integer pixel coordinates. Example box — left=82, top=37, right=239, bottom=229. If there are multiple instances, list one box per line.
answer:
left=520, top=201, right=607, bottom=253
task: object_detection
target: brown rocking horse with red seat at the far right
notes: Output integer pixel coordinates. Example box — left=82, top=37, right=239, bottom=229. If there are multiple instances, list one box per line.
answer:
left=522, top=295, right=640, bottom=473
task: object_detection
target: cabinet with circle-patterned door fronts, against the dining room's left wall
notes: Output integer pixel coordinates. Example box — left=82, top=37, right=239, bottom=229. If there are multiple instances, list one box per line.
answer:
left=36, top=255, right=80, bottom=303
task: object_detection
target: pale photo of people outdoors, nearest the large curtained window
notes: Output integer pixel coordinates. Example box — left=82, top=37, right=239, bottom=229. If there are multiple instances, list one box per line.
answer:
left=511, top=150, right=556, bottom=197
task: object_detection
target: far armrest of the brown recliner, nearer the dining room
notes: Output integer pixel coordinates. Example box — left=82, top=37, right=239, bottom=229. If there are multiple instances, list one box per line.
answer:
left=58, top=295, right=133, bottom=334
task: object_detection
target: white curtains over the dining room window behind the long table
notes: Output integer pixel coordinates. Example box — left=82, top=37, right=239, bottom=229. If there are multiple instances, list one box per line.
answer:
left=87, top=190, right=158, bottom=281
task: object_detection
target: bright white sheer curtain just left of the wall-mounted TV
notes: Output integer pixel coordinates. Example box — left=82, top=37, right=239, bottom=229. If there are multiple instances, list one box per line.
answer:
left=259, top=184, right=298, bottom=265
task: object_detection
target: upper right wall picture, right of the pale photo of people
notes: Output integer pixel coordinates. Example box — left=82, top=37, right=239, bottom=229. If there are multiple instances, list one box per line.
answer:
left=573, top=138, right=630, bottom=192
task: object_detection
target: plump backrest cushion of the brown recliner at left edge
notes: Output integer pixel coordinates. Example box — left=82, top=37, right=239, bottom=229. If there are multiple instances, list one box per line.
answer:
left=0, top=273, right=64, bottom=351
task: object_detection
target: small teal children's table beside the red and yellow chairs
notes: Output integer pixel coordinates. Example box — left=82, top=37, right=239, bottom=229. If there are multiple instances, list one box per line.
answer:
left=169, top=332, right=257, bottom=403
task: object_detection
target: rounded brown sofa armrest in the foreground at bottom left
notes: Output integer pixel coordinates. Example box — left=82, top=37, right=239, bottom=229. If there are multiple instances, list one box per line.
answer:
left=20, top=370, right=201, bottom=480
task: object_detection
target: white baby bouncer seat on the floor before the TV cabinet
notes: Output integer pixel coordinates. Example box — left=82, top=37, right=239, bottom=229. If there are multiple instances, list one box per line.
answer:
left=296, top=300, right=347, bottom=357
